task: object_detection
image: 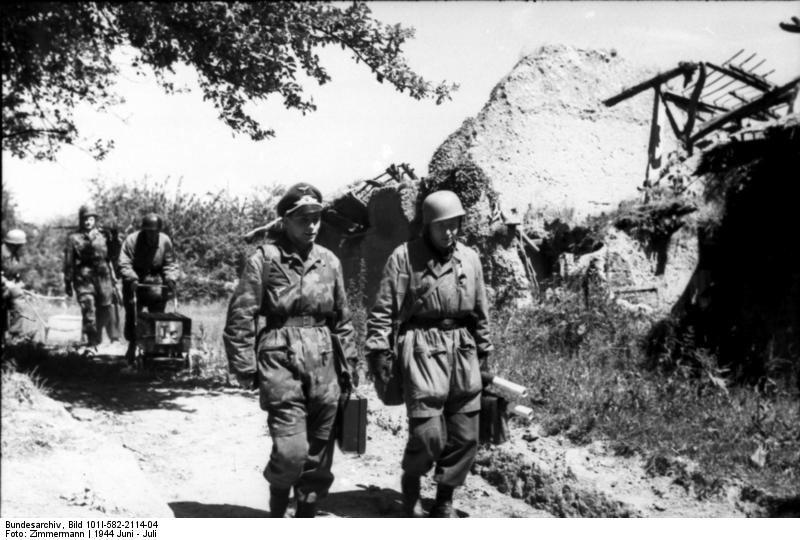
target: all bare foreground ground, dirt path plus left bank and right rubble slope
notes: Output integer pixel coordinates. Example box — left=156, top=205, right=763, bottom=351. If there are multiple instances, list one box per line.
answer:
left=3, top=357, right=752, bottom=517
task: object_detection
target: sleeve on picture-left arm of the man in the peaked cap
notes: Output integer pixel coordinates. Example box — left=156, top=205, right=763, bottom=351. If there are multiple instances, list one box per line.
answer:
left=222, top=250, right=264, bottom=375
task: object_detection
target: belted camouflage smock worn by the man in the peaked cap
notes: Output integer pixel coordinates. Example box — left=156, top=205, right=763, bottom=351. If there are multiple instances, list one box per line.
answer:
left=223, top=235, right=357, bottom=439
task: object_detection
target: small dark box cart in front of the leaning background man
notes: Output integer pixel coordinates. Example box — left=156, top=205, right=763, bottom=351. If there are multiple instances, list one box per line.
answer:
left=133, top=283, right=192, bottom=372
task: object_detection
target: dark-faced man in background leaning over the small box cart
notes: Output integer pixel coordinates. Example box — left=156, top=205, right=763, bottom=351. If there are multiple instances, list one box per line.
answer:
left=119, top=213, right=178, bottom=362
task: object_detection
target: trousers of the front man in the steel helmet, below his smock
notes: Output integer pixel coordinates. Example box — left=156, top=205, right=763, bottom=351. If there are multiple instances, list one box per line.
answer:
left=402, top=411, right=480, bottom=487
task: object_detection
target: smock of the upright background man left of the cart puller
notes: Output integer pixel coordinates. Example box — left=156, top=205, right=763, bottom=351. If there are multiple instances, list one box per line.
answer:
left=64, top=229, right=113, bottom=306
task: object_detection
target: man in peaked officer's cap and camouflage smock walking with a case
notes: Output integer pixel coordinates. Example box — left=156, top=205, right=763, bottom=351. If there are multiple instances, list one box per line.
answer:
left=223, top=183, right=356, bottom=517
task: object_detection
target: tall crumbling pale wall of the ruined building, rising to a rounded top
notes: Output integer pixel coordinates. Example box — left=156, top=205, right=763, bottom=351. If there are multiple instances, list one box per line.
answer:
left=424, top=46, right=666, bottom=304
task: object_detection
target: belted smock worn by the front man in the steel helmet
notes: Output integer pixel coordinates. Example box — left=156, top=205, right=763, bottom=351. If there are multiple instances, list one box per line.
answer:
left=366, top=238, right=492, bottom=417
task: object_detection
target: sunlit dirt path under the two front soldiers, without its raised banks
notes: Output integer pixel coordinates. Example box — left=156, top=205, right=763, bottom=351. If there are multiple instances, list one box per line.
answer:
left=45, top=358, right=550, bottom=517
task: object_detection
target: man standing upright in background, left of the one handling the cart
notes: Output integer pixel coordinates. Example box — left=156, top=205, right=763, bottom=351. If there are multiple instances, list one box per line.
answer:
left=64, top=204, right=119, bottom=347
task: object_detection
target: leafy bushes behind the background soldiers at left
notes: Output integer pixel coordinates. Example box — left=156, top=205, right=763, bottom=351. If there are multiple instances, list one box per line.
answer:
left=3, top=179, right=285, bottom=301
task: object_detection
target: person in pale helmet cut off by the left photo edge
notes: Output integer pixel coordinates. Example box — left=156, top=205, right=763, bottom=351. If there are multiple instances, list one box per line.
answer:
left=2, top=229, right=33, bottom=341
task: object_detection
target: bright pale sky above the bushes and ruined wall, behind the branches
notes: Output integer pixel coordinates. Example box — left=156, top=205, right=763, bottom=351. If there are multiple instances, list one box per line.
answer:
left=2, top=2, right=800, bottom=222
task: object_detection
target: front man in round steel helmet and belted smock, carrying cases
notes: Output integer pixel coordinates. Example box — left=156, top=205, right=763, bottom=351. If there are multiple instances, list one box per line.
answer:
left=366, top=190, right=492, bottom=517
